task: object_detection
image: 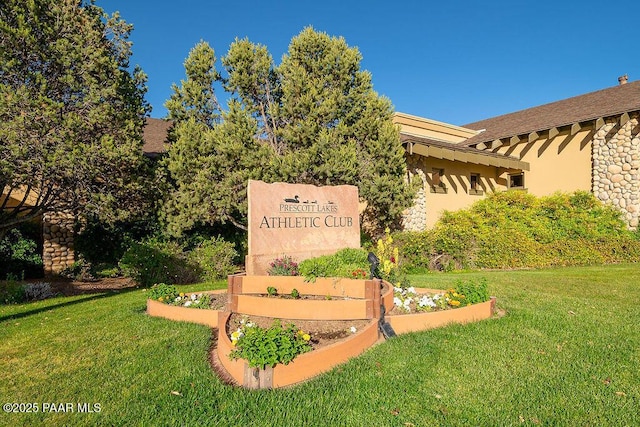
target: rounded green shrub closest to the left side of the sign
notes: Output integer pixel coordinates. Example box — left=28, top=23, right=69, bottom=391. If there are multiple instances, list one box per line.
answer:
left=188, top=237, right=238, bottom=281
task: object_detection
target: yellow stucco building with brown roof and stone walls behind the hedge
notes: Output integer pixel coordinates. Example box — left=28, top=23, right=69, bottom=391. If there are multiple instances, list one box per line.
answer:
left=394, top=80, right=640, bottom=230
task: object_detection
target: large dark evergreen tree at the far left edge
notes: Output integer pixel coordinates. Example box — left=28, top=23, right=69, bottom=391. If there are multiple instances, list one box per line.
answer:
left=0, top=0, right=149, bottom=239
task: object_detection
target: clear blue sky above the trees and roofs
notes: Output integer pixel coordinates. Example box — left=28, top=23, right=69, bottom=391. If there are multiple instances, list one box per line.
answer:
left=104, top=0, right=640, bottom=125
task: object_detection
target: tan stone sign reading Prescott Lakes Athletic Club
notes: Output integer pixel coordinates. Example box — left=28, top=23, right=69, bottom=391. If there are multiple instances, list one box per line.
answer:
left=246, top=181, right=360, bottom=274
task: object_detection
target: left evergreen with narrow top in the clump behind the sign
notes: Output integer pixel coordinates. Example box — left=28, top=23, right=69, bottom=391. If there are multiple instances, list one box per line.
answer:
left=162, top=42, right=267, bottom=236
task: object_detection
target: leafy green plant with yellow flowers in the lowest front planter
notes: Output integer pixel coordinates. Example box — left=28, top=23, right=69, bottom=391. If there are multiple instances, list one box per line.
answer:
left=229, top=319, right=312, bottom=369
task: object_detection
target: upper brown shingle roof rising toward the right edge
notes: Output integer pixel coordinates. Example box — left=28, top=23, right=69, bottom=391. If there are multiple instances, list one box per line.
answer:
left=460, top=80, right=640, bottom=146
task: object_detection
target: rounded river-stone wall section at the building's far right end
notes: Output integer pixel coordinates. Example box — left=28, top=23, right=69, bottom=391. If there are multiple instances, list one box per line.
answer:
left=592, top=113, right=640, bottom=229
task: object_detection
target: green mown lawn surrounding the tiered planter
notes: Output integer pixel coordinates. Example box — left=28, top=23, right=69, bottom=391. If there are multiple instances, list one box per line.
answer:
left=0, top=264, right=640, bottom=426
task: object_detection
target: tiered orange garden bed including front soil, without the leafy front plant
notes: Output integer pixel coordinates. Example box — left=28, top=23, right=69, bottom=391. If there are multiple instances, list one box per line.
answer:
left=147, top=275, right=495, bottom=388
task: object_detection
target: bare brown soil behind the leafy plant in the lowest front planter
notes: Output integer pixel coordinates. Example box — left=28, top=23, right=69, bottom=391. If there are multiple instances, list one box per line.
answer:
left=227, top=313, right=371, bottom=350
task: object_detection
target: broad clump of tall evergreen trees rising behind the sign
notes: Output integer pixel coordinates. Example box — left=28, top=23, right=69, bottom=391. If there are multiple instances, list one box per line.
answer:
left=160, top=28, right=411, bottom=234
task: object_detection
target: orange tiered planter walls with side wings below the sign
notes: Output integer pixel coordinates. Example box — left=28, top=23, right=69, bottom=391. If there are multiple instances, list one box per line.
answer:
left=147, top=275, right=496, bottom=388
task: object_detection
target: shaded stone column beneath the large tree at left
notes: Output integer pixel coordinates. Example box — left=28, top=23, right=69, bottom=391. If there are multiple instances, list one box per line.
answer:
left=42, top=212, right=75, bottom=276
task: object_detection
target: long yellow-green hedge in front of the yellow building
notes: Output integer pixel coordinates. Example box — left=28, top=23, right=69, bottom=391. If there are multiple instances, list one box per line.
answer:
left=394, top=191, right=640, bottom=270
